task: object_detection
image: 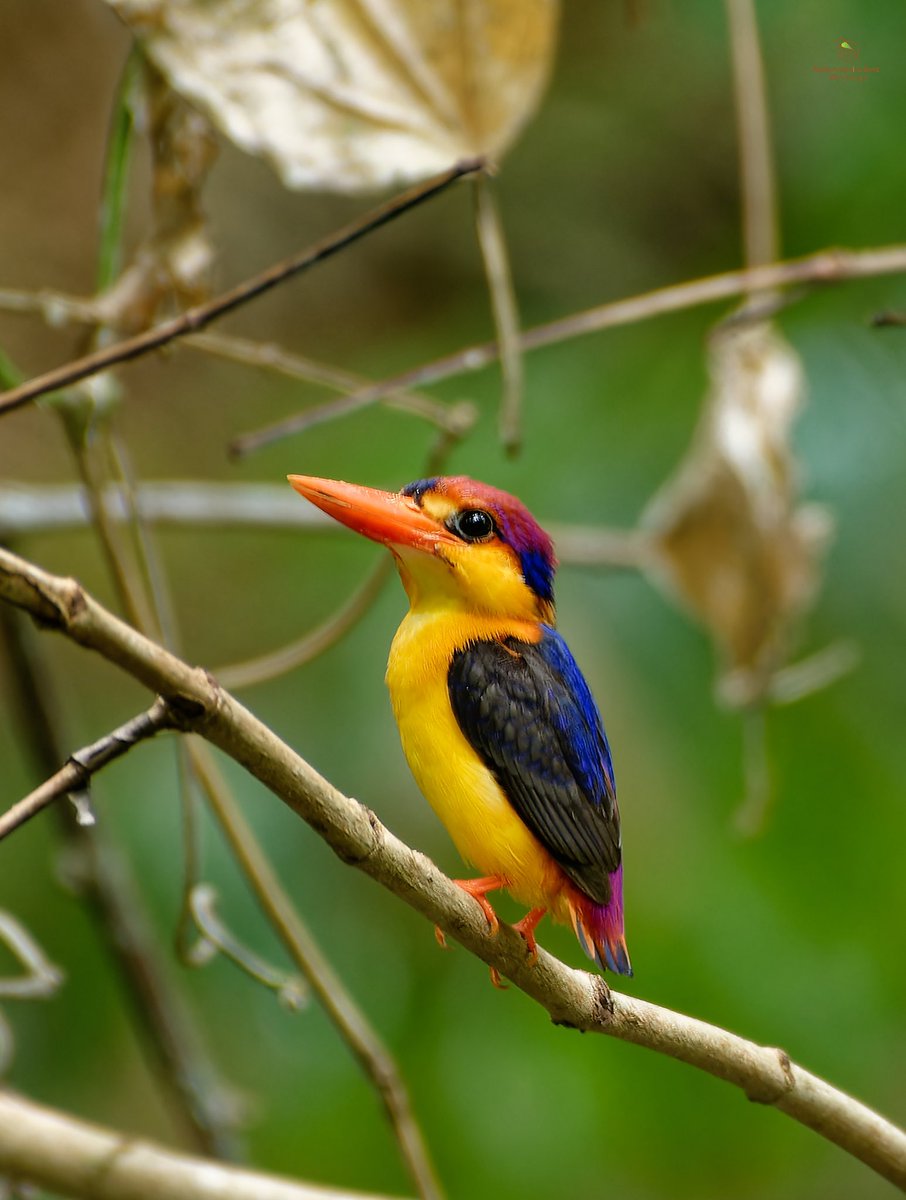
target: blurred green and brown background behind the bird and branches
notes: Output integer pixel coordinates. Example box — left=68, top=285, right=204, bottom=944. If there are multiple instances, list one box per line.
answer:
left=0, top=0, right=906, bottom=1200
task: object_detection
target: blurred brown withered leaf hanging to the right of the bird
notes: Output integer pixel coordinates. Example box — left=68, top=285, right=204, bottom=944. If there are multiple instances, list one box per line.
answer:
left=643, top=322, right=832, bottom=704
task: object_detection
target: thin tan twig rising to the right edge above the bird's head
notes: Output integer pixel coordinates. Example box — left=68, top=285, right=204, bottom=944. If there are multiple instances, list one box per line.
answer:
left=234, top=246, right=906, bottom=452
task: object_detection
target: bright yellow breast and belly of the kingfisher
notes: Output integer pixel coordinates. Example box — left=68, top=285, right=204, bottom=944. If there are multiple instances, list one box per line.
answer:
left=386, top=613, right=566, bottom=919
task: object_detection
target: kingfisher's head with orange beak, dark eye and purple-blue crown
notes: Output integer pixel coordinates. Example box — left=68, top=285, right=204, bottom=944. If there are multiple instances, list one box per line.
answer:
left=294, top=475, right=556, bottom=623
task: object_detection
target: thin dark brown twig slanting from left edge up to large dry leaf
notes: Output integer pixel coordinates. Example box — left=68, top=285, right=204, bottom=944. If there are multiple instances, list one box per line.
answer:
left=0, top=158, right=485, bottom=415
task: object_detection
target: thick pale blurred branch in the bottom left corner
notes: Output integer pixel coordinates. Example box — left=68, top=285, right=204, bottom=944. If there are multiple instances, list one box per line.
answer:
left=0, top=1092, right=408, bottom=1200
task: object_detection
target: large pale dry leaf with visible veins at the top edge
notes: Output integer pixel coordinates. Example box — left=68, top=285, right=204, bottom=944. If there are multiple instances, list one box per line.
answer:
left=97, top=0, right=557, bottom=191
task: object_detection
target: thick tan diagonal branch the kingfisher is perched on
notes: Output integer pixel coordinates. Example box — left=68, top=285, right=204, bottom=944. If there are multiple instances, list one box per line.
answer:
left=0, top=550, right=906, bottom=1187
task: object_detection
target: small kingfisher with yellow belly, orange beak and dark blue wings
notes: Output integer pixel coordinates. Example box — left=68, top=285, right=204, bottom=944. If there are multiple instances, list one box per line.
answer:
left=288, top=475, right=632, bottom=983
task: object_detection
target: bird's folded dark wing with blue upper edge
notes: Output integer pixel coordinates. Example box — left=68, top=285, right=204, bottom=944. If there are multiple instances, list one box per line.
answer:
left=448, top=626, right=620, bottom=904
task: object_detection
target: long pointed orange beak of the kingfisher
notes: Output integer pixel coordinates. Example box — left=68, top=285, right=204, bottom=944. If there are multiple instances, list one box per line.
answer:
left=287, top=475, right=456, bottom=553
